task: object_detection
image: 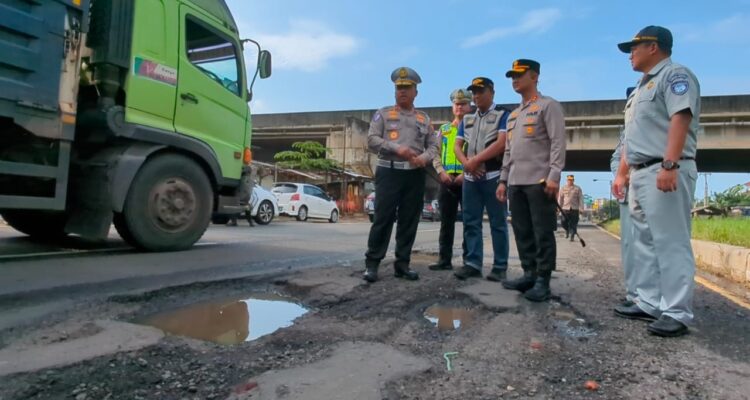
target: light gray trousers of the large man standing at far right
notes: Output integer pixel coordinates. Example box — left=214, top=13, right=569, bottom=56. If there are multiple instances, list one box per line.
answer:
left=628, top=160, right=698, bottom=324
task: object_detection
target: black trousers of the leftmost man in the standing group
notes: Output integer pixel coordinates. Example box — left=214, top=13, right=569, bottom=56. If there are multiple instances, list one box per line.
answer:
left=365, top=167, right=425, bottom=268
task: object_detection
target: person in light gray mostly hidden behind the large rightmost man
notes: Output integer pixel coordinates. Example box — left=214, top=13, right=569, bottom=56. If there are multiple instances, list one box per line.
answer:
left=609, top=87, right=638, bottom=307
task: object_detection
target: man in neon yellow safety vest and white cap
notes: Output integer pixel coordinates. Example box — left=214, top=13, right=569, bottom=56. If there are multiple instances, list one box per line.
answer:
left=428, top=89, right=471, bottom=271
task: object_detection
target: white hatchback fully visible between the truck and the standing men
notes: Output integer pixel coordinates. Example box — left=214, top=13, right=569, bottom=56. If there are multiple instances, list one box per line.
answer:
left=271, top=182, right=339, bottom=223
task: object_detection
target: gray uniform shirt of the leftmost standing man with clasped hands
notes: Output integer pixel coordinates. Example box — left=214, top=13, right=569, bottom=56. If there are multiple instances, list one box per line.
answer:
left=367, top=106, right=438, bottom=164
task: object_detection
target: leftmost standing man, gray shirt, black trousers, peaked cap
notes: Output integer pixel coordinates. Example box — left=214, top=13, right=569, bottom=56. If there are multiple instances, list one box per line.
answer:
left=364, top=67, right=437, bottom=282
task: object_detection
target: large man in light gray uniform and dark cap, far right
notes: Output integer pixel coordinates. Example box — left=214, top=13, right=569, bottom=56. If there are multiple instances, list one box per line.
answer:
left=612, top=26, right=701, bottom=337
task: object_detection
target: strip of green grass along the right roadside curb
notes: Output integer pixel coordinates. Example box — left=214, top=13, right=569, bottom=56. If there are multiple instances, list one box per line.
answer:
left=602, top=218, right=750, bottom=248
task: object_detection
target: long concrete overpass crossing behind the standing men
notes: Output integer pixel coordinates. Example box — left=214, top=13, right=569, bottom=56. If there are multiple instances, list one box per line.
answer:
left=253, top=95, right=750, bottom=173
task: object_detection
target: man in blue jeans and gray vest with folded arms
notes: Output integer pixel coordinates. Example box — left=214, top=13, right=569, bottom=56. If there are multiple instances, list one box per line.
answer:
left=454, top=77, right=510, bottom=282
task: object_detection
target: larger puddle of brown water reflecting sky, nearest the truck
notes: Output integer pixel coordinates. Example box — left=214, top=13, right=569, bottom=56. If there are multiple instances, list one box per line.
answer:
left=140, top=293, right=308, bottom=345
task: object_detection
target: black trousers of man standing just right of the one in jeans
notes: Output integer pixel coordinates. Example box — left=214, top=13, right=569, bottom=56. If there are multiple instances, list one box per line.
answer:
left=508, top=185, right=557, bottom=275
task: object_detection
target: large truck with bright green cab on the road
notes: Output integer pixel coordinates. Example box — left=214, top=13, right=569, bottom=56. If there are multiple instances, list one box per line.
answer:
left=0, top=0, right=271, bottom=251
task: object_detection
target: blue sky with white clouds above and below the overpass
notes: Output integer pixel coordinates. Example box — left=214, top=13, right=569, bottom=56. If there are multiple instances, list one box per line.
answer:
left=227, top=0, right=750, bottom=198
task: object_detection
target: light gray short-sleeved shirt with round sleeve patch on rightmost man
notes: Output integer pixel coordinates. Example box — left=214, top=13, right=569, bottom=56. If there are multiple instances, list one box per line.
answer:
left=625, top=58, right=701, bottom=165
